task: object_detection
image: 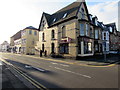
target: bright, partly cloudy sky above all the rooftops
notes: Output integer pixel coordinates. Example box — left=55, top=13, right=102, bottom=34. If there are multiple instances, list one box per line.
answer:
left=0, top=0, right=118, bottom=44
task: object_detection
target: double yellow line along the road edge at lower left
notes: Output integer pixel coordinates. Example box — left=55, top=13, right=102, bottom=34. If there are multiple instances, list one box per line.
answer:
left=0, top=58, right=48, bottom=90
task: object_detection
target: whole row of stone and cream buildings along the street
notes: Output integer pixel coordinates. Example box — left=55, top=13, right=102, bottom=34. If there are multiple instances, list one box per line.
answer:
left=10, top=2, right=120, bottom=57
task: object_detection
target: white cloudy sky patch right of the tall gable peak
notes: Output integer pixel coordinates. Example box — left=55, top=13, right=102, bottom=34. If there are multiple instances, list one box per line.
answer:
left=88, top=1, right=118, bottom=27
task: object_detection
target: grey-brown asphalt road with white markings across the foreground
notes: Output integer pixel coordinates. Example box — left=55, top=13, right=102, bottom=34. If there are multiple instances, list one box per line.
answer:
left=0, top=53, right=118, bottom=88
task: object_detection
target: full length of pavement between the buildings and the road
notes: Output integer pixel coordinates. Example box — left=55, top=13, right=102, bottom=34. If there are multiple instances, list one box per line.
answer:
left=1, top=53, right=120, bottom=67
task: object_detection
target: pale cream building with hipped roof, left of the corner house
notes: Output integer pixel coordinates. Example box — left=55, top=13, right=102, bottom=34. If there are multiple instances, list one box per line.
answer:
left=11, top=26, right=39, bottom=54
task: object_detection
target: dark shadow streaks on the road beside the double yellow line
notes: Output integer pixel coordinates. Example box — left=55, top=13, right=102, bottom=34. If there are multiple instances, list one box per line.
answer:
left=5, top=59, right=61, bottom=88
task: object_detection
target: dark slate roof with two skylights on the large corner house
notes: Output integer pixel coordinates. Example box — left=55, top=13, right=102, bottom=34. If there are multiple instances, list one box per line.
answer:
left=39, top=2, right=88, bottom=29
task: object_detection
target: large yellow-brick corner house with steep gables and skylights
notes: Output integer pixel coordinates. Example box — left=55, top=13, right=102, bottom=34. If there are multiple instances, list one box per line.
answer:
left=37, top=2, right=94, bottom=57
